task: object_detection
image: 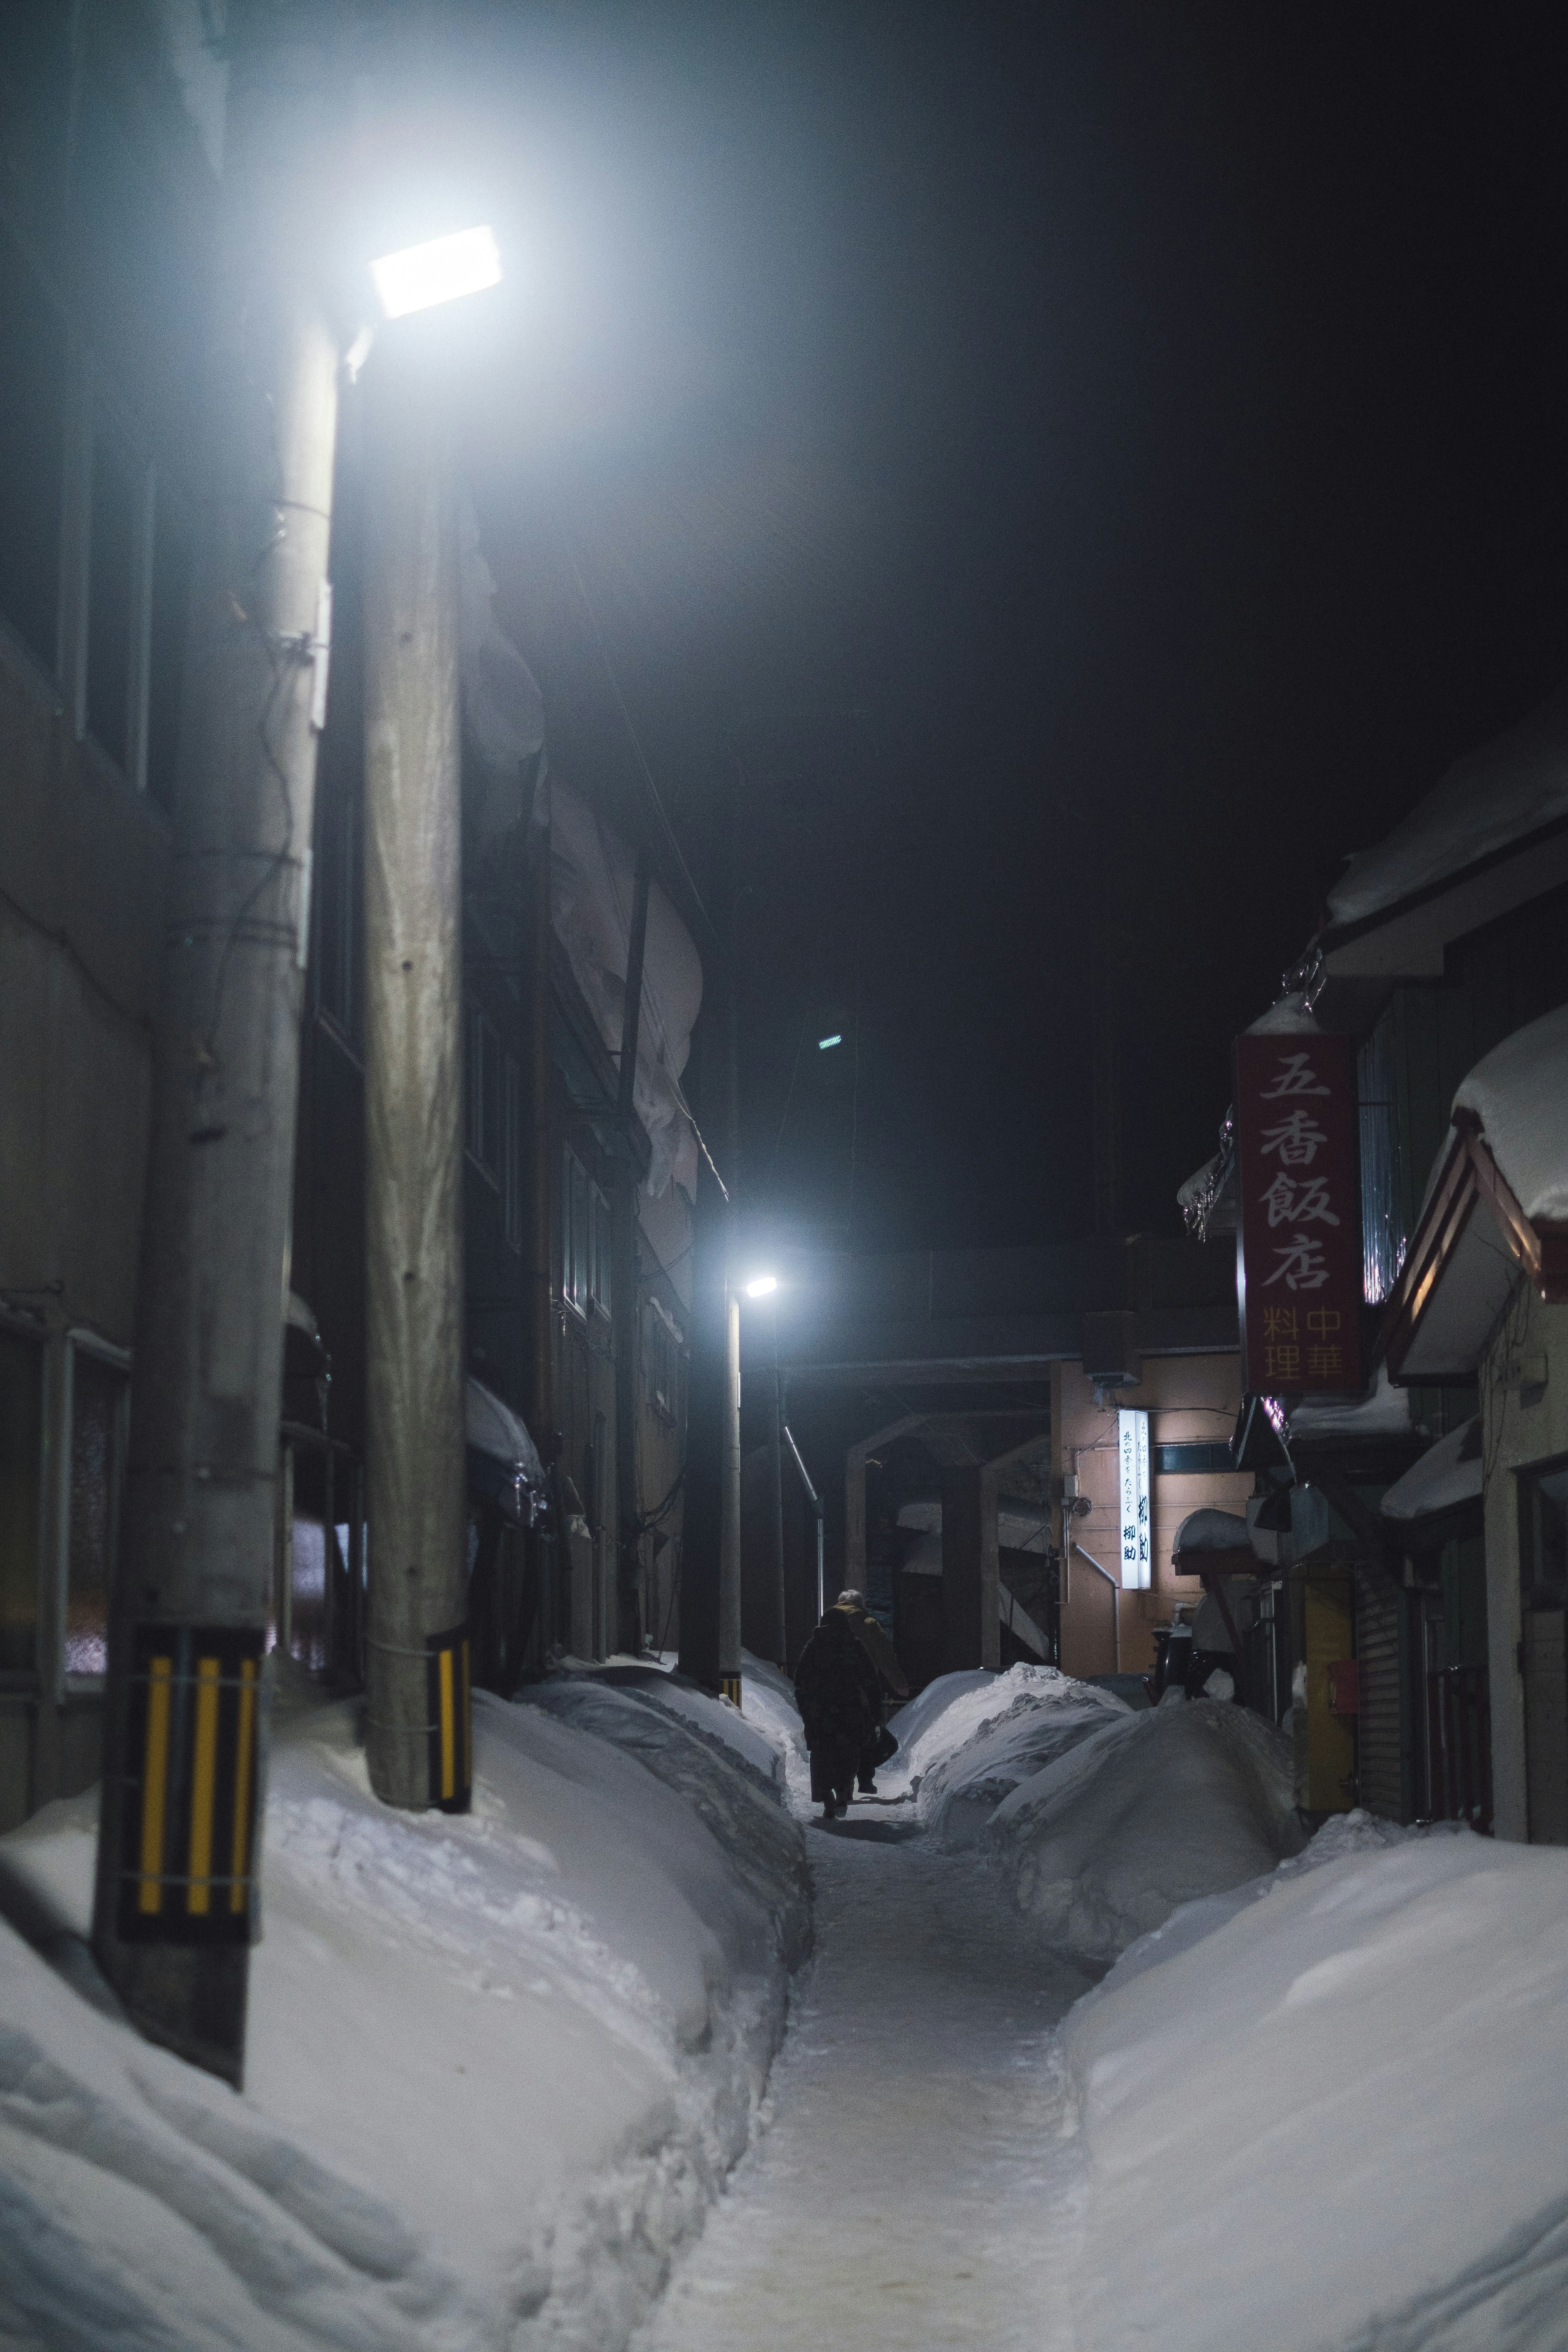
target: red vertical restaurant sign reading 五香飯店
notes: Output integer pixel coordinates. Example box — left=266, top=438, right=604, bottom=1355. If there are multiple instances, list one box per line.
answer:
left=1236, top=1033, right=1363, bottom=1397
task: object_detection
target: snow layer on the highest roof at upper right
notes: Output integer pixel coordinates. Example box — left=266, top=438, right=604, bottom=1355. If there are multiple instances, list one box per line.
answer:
left=1328, top=687, right=1568, bottom=924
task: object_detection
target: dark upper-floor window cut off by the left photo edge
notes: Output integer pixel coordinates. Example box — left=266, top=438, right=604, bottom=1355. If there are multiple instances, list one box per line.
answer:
left=0, top=233, right=66, bottom=670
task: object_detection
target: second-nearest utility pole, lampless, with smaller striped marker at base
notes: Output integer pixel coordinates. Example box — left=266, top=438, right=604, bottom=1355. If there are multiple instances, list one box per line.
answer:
left=364, top=341, right=472, bottom=1811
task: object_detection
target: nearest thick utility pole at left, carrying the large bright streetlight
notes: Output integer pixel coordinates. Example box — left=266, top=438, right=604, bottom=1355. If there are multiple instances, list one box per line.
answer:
left=94, top=0, right=339, bottom=2084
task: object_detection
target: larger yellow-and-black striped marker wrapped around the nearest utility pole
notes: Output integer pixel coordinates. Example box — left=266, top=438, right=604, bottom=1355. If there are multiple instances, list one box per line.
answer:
left=120, top=1625, right=263, bottom=1943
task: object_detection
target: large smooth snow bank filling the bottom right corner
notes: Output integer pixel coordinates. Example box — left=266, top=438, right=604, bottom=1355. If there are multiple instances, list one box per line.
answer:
left=1065, top=1834, right=1568, bottom=2352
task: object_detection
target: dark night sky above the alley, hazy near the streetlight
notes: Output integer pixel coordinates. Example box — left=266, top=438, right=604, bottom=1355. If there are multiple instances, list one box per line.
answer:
left=442, top=0, right=1568, bottom=1247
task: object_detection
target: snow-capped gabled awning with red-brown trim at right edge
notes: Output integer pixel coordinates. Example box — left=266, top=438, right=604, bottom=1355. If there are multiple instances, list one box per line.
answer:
left=1382, top=1007, right=1568, bottom=1381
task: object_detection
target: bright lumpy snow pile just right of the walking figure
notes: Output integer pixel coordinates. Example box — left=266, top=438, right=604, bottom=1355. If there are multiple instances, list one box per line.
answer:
left=886, top=1665, right=1128, bottom=1849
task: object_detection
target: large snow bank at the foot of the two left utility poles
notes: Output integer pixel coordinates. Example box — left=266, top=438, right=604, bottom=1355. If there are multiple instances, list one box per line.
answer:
left=0, top=1693, right=804, bottom=2352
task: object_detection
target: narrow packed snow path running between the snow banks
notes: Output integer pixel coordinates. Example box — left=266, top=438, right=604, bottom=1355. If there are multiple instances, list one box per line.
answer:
left=637, top=1799, right=1089, bottom=2352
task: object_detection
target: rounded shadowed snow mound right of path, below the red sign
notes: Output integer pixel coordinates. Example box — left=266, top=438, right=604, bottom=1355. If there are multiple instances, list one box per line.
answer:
left=985, top=1698, right=1302, bottom=1964
